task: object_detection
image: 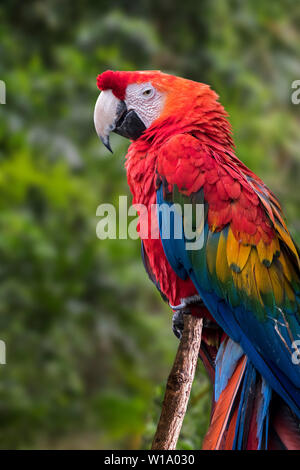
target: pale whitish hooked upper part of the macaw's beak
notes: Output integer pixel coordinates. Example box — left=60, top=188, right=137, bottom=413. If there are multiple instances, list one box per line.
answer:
left=94, top=90, right=120, bottom=152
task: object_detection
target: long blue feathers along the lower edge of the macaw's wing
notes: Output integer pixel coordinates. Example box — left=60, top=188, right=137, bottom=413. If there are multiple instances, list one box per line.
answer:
left=157, top=187, right=300, bottom=418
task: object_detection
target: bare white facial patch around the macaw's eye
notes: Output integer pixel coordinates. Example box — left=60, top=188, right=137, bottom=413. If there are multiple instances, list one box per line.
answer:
left=125, top=82, right=165, bottom=128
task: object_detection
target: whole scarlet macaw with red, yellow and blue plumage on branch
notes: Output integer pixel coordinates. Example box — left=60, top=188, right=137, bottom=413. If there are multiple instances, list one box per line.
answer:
left=94, top=70, right=300, bottom=450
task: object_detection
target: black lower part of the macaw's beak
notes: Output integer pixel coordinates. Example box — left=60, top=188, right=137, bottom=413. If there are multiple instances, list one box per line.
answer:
left=113, top=101, right=146, bottom=140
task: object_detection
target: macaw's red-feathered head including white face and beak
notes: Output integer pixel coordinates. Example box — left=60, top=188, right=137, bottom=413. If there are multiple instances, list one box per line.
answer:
left=94, top=70, right=231, bottom=151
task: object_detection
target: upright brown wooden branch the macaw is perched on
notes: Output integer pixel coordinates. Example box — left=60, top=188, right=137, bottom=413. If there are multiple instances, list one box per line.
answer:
left=152, top=315, right=203, bottom=450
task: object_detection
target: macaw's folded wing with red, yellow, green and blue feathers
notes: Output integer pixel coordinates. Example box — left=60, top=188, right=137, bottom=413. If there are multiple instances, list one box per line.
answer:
left=157, top=134, right=300, bottom=416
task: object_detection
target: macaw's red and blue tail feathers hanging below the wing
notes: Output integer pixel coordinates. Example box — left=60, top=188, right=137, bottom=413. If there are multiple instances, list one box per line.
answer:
left=203, top=337, right=300, bottom=450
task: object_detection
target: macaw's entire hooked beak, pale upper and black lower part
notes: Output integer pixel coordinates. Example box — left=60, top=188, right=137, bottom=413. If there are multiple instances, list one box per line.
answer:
left=94, top=90, right=146, bottom=152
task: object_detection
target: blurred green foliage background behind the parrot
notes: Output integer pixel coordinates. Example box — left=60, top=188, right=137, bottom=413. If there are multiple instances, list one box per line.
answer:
left=0, top=0, right=300, bottom=449
